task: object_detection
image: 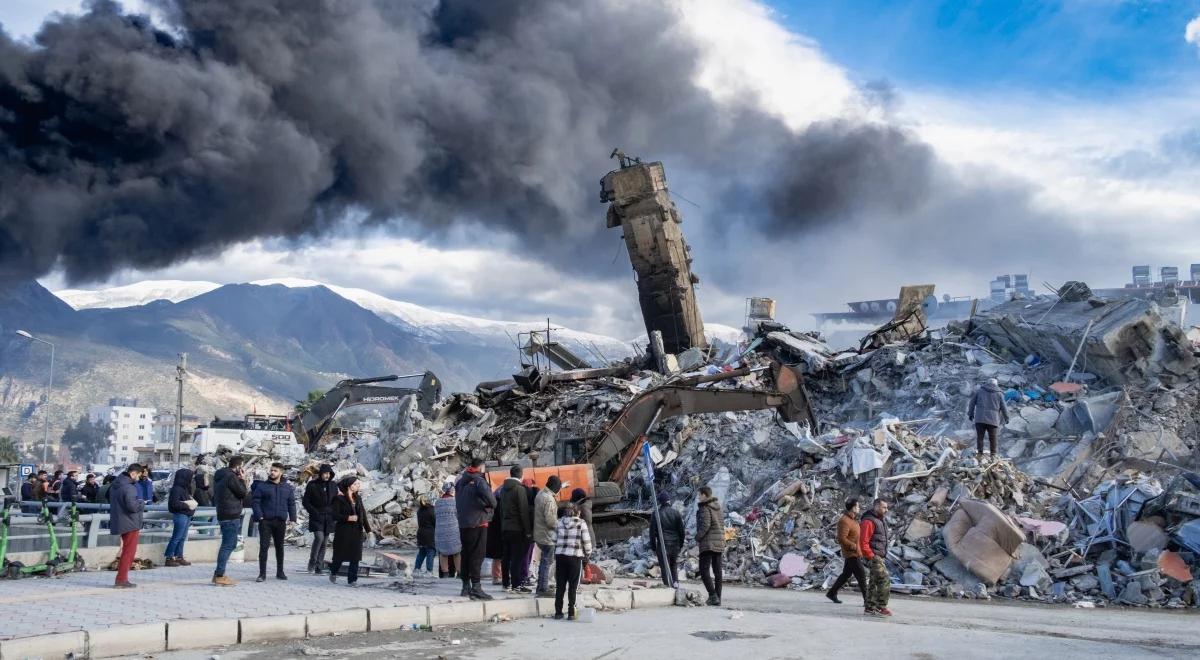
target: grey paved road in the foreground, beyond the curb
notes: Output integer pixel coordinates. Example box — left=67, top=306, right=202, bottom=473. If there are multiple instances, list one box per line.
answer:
left=133, top=588, right=1200, bottom=660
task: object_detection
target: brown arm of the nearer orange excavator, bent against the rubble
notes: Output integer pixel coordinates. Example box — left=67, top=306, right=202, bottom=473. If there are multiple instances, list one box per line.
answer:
left=586, top=362, right=817, bottom=484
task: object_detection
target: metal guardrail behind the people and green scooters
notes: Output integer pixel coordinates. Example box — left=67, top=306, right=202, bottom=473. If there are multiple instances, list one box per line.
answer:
left=8, top=502, right=252, bottom=553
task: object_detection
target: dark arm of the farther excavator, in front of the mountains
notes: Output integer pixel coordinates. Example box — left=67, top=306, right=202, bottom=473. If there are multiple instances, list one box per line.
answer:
left=292, top=371, right=442, bottom=451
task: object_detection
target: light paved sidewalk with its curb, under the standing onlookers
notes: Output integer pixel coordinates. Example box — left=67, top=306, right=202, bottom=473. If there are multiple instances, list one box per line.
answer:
left=0, top=547, right=673, bottom=660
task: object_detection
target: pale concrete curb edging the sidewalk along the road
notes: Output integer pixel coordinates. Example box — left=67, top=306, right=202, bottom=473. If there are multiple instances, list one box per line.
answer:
left=0, top=588, right=674, bottom=660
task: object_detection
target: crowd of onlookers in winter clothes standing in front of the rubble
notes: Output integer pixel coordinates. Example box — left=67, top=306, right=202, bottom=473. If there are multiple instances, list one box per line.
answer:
left=22, top=456, right=739, bottom=619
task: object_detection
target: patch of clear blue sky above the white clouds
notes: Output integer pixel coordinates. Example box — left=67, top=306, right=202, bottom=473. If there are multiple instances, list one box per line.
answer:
left=772, top=0, right=1200, bottom=97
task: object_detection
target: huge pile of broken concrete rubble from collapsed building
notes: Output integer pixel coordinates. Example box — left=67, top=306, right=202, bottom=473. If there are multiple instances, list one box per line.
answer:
left=211, top=282, right=1200, bottom=607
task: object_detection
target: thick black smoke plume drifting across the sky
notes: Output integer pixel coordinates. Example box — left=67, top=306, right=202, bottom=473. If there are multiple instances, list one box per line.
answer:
left=0, top=0, right=940, bottom=282
